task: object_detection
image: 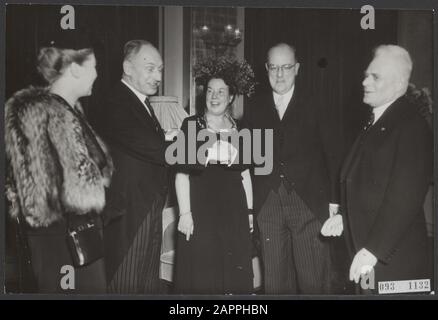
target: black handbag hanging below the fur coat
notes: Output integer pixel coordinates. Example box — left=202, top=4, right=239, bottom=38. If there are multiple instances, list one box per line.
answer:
left=67, top=214, right=104, bottom=267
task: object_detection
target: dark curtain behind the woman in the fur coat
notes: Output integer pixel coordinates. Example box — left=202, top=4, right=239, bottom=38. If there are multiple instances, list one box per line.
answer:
left=5, top=5, right=158, bottom=128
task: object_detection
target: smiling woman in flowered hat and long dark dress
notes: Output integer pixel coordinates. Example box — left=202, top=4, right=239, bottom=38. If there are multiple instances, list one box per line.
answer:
left=175, top=60, right=254, bottom=294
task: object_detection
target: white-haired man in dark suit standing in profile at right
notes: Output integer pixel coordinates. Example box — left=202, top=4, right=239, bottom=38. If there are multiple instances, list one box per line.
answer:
left=341, top=45, right=433, bottom=292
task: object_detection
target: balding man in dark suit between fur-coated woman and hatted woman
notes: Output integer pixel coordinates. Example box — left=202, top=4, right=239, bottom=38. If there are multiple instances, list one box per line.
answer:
left=103, top=40, right=176, bottom=293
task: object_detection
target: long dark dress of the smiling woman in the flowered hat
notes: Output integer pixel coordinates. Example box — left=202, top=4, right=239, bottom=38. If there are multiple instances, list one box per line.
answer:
left=175, top=116, right=253, bottom=294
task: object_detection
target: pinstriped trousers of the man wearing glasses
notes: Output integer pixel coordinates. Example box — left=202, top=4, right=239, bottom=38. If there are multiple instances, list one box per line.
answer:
left=257, top=183, right=330, bottom=294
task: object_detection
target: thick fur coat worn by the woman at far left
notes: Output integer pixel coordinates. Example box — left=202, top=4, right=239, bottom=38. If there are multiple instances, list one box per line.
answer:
left=5, top=87, right=113, bottom=227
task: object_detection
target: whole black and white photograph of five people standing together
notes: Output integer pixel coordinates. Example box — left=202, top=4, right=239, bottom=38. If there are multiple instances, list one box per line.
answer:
left=0, top=2, right=437, bottom=298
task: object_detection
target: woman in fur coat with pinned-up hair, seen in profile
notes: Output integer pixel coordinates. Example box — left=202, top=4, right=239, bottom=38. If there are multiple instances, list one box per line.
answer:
left=5, top=47, right=112, bottom=293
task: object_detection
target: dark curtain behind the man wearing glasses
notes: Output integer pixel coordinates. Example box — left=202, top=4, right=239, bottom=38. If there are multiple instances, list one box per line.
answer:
left=245, top=8, right=397, bottom=149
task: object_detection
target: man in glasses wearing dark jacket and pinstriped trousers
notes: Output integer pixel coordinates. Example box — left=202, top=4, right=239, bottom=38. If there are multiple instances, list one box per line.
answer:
left=244, top=43, right=341, bottom=294
